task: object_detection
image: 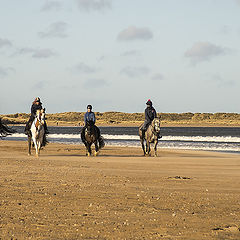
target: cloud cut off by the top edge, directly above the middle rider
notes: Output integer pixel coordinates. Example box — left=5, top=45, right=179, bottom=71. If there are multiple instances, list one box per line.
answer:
left=76, top=0, right=112, bottom=11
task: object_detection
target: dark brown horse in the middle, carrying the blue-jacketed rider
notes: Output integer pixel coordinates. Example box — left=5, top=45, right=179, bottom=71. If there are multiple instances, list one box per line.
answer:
left=82, top=121, right=104, bottom=156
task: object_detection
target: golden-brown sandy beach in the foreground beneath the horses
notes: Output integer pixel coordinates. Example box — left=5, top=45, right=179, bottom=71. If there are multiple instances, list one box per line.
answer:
left=0, top=141, right=240, bottom=240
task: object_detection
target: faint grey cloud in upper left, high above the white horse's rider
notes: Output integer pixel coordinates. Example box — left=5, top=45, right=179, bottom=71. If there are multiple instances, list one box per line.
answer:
left=38, top=22, right=68, bottom=38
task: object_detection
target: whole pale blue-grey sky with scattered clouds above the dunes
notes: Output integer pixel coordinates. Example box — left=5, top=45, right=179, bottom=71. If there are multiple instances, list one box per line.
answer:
left=0, top=0, right=240, bottom=114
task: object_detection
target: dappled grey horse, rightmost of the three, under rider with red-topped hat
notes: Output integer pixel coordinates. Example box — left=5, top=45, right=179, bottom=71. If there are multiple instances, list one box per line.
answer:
left=139, top=118, right=161, bottom=157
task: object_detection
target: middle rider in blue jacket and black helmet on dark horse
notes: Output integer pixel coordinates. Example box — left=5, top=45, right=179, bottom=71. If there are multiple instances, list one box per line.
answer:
left=81, top=105, right=104, bottom=148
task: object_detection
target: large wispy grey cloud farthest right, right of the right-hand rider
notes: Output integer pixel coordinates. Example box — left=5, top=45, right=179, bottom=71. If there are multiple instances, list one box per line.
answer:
left=185, top=42, right=230, bottom=64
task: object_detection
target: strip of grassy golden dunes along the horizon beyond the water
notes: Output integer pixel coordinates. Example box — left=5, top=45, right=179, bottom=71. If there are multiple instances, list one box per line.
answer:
left=0, top=112, right=240, bottom=126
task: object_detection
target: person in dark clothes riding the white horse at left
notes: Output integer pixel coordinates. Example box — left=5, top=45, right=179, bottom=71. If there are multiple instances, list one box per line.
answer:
left=24, top=97, right=49, bottom=146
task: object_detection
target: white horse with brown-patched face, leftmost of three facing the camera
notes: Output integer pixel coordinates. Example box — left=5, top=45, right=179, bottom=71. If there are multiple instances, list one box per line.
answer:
left=28, top=108, right=45, bottom=157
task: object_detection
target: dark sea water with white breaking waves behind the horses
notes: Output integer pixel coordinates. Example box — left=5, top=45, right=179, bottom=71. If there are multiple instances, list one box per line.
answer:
left=4, top=126, right=240, bottom=153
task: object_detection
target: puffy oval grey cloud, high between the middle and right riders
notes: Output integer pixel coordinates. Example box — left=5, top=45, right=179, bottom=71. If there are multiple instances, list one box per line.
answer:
left=117, top=26, right=153, bottom=41
